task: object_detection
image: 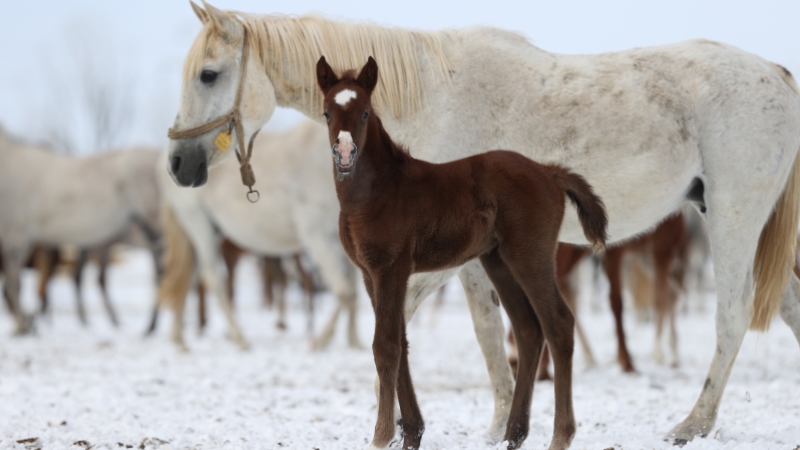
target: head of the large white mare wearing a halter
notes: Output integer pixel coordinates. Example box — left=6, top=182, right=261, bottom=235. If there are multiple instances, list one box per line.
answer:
left=169, top=2, right=276, bottom=187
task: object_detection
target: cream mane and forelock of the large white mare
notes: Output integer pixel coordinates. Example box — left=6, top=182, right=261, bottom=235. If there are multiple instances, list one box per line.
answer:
left=184, top=12, right=453, bottom=117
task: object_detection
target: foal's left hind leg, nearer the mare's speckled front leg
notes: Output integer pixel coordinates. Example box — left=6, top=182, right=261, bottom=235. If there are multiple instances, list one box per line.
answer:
left=481, top=250, right=544, bottom=449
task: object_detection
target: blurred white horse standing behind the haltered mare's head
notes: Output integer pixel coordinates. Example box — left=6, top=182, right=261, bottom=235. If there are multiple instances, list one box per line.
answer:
left=159, top=121, right=360, bottom=349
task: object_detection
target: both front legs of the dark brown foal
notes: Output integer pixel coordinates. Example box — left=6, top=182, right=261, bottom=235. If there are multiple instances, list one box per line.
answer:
left=364, top=264, right=423, bottom=448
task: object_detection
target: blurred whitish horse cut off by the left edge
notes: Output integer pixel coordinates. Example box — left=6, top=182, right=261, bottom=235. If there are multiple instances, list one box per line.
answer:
left=0, top=126, right=160, bottom=334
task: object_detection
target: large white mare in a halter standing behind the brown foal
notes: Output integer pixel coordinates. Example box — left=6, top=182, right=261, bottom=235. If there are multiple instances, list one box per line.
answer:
left=164, top=5, right=800, bottom=442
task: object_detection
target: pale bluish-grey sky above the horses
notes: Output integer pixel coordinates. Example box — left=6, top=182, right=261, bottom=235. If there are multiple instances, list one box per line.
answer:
left=0, top=0, right=800, bottom=153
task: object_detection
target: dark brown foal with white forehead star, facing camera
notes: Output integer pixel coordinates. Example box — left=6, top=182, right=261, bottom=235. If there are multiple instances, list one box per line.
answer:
left=317, top=57, right=607, bottom=449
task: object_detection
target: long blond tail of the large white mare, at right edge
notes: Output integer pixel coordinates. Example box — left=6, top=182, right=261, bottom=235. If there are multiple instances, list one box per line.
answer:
left=750, top=64, right=800, bottom=331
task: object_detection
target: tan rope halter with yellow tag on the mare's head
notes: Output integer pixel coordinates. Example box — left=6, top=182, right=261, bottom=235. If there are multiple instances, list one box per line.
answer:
left=167, top=27, right=261, bottom=203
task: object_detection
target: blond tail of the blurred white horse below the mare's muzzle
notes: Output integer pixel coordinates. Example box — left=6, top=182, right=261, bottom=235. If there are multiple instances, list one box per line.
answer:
left=157, top=201, right=195, bottom=310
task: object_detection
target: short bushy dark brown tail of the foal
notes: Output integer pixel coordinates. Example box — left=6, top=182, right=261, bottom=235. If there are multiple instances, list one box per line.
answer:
left=551, top=166, right=608, bottom=250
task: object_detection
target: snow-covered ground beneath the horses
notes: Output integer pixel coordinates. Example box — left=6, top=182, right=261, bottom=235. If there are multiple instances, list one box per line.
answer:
left=0, top=251, right=800, bottom=450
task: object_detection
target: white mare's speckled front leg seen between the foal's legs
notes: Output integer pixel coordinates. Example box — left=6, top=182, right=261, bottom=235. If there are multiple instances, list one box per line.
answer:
left=458, top=259, right=514, bottom=442
